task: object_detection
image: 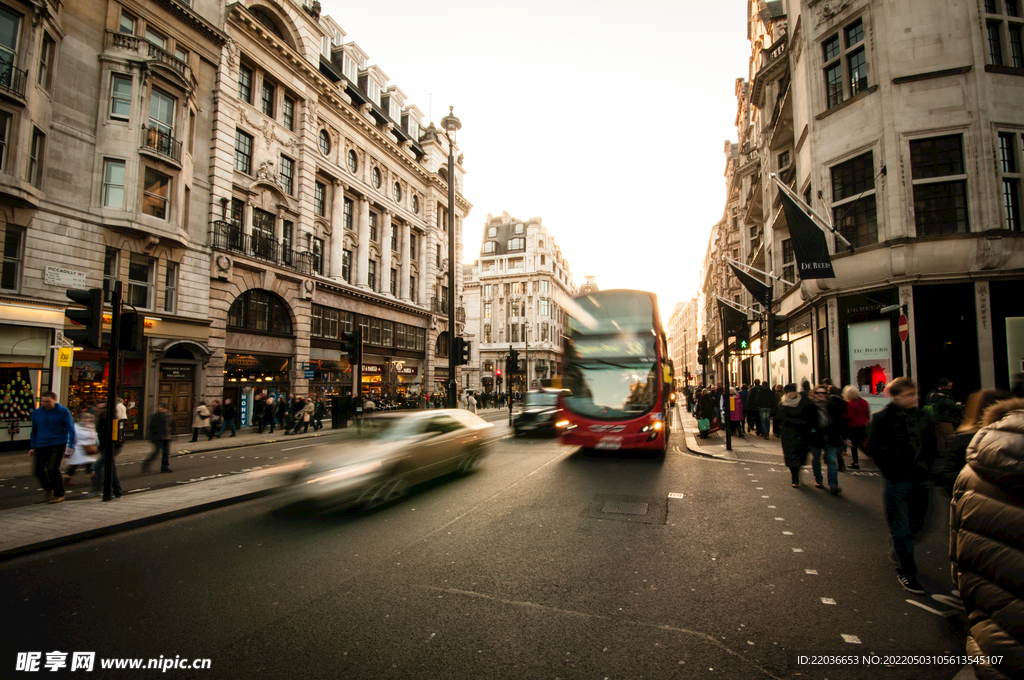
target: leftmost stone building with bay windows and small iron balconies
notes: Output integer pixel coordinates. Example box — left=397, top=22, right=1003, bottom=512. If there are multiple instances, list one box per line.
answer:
left=0, top=0, right=225, bottom=445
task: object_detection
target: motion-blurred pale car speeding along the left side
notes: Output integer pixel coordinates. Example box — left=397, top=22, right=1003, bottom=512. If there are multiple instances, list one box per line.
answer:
left=285, top=410, right=495, bottom=509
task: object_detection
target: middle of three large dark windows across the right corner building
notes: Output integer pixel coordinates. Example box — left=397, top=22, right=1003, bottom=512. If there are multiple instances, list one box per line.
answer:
left=910, top=134, right=970, bottom=237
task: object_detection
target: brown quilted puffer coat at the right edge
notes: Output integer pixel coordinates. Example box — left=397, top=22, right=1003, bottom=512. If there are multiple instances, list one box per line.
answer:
left=949, top=398, right=1024, bottom=680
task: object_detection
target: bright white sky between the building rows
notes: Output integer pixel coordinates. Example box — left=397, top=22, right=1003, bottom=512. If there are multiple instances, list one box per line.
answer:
left=323, top=0, right=750, bottom=318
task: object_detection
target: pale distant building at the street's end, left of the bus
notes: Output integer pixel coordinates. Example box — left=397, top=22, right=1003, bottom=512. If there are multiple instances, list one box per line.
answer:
left=465, top=212, right=575, bottom=392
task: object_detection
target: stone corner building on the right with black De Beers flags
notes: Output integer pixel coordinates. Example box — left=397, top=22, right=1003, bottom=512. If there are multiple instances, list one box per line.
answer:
left=700, top=0, right=1024, bottom=406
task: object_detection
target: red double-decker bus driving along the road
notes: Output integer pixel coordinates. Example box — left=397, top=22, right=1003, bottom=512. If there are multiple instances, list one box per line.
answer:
left=559, top=290, right=674, bottom=456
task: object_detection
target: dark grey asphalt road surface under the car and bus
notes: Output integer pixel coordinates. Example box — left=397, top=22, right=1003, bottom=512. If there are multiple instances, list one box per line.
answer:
left=0, top=417, right=963, bottom=679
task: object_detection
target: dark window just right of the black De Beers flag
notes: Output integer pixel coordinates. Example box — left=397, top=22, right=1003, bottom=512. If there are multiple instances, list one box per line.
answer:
left=827, top=152, right=879, bottom=250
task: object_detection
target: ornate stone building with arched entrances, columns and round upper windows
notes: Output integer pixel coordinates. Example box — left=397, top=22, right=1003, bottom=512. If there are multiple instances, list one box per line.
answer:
left=206, top=1, right=471, bottom=412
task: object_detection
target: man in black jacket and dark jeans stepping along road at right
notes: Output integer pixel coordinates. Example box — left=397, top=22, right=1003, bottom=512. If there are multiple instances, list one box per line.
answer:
left=867, top=377, right=938, bottom=595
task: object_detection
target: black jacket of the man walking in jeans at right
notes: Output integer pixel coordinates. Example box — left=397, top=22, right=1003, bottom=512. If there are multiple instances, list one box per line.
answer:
left=867, top=402, right=938, bottom=481
